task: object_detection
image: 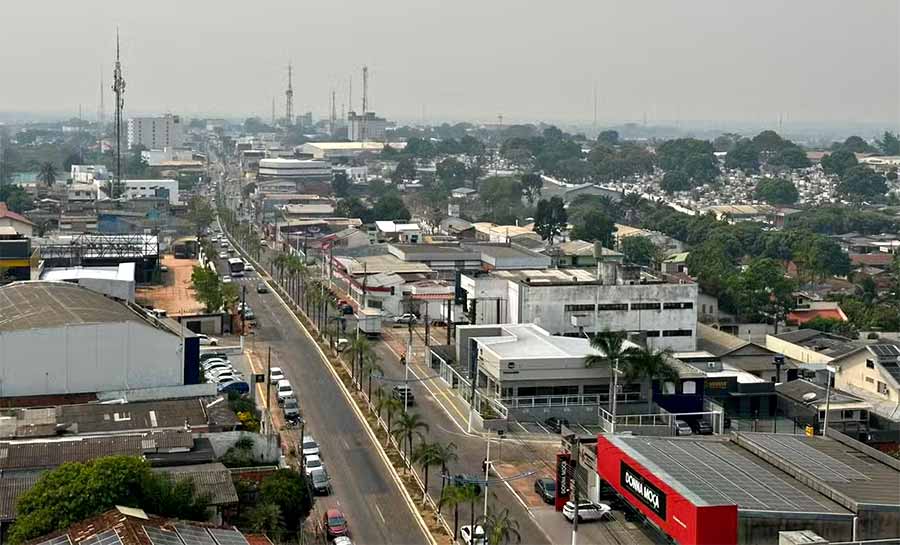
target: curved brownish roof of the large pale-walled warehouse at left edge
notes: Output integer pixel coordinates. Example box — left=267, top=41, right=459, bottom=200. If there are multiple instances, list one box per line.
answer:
left=0, top=281, right=149, bottom=331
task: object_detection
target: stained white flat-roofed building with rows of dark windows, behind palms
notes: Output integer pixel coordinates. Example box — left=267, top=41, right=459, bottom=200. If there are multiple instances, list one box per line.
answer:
left=459, top=263, right=698, bottom=351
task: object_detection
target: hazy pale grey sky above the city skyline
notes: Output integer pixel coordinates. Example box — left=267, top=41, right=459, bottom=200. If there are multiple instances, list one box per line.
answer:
left=0, top=0, right=900, bottom=124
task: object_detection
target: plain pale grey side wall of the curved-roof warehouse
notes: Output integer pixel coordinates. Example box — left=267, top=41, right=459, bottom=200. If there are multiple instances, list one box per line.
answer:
left=0, top=322, right=184, bottom=396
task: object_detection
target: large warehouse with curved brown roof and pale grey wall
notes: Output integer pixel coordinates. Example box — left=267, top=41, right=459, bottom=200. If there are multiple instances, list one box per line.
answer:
left=0, top=282, right=199, bottom=397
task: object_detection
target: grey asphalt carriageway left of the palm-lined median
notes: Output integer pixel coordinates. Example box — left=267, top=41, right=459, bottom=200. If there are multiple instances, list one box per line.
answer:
left=218, top=227, right=428, bottom=545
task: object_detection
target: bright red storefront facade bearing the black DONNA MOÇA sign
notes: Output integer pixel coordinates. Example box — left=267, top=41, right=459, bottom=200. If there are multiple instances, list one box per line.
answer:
left=596, top=435, right=737, bottom=545
